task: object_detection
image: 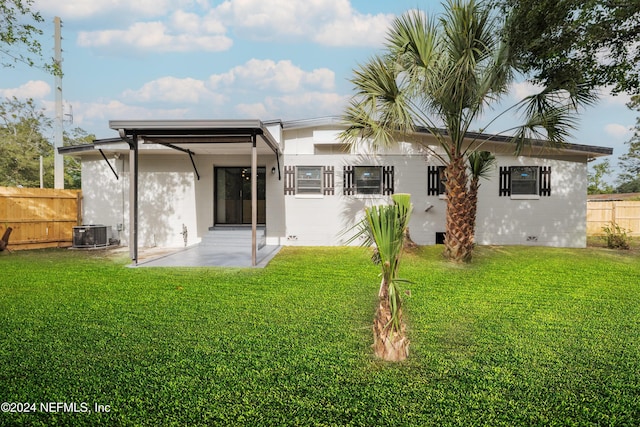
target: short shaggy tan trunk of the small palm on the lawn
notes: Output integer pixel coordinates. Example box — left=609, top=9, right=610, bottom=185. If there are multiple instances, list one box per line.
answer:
left=373, top=278, right=409, bottom=362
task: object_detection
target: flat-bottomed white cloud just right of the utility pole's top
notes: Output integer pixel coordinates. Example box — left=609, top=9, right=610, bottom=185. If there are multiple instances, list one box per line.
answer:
left=78, top=11, right=233, bottom=52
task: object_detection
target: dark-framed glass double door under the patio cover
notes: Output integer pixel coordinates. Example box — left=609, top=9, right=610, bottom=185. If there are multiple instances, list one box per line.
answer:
left=214, top=167, right=266, bottom=225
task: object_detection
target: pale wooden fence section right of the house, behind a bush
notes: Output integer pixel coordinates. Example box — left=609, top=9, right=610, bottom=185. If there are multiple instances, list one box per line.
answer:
left=587, top=200, right=640, bottom=236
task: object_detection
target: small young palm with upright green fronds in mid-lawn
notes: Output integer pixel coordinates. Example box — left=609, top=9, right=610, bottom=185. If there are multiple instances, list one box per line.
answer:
left=351, top=194, right=412, bottom=361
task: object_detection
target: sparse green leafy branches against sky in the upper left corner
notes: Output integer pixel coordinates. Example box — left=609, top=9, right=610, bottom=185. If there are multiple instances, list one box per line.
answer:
left=0, top=0, right=60, bottom=74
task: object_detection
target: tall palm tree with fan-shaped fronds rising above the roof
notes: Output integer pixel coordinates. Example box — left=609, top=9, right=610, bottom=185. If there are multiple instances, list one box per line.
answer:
left=341, top=0, right=592, bottom=261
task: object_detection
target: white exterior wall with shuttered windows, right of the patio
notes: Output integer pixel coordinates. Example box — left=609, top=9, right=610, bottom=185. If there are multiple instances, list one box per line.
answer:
left=281, top=129, right=587, bottom=247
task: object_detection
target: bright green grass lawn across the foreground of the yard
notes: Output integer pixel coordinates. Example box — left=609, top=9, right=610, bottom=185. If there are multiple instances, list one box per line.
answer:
left=0, top=247, right=640, bottom=426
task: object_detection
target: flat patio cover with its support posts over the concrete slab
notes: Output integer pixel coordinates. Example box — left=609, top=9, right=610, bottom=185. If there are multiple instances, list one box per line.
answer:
left=109, top=120, right=281, bottom=266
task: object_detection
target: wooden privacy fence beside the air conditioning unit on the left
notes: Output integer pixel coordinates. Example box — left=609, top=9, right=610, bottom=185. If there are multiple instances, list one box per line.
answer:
left=0, top=187, right=82, bottom=250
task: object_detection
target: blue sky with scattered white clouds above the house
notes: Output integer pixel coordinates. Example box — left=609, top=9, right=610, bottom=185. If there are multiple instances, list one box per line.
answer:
left=0, top=0, right=636, bottom=179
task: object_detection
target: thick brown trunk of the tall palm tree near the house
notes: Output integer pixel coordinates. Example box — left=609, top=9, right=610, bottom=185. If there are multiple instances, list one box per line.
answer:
left=444, top=155, right=473, bottom=262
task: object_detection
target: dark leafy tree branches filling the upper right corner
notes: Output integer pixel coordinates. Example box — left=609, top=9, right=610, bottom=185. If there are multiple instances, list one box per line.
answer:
left=494, top=0, right=640, bottom=94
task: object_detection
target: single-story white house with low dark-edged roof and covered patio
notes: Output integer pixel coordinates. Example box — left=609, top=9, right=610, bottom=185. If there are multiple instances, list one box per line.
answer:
left=60, top=118, right=612, bottom=264
